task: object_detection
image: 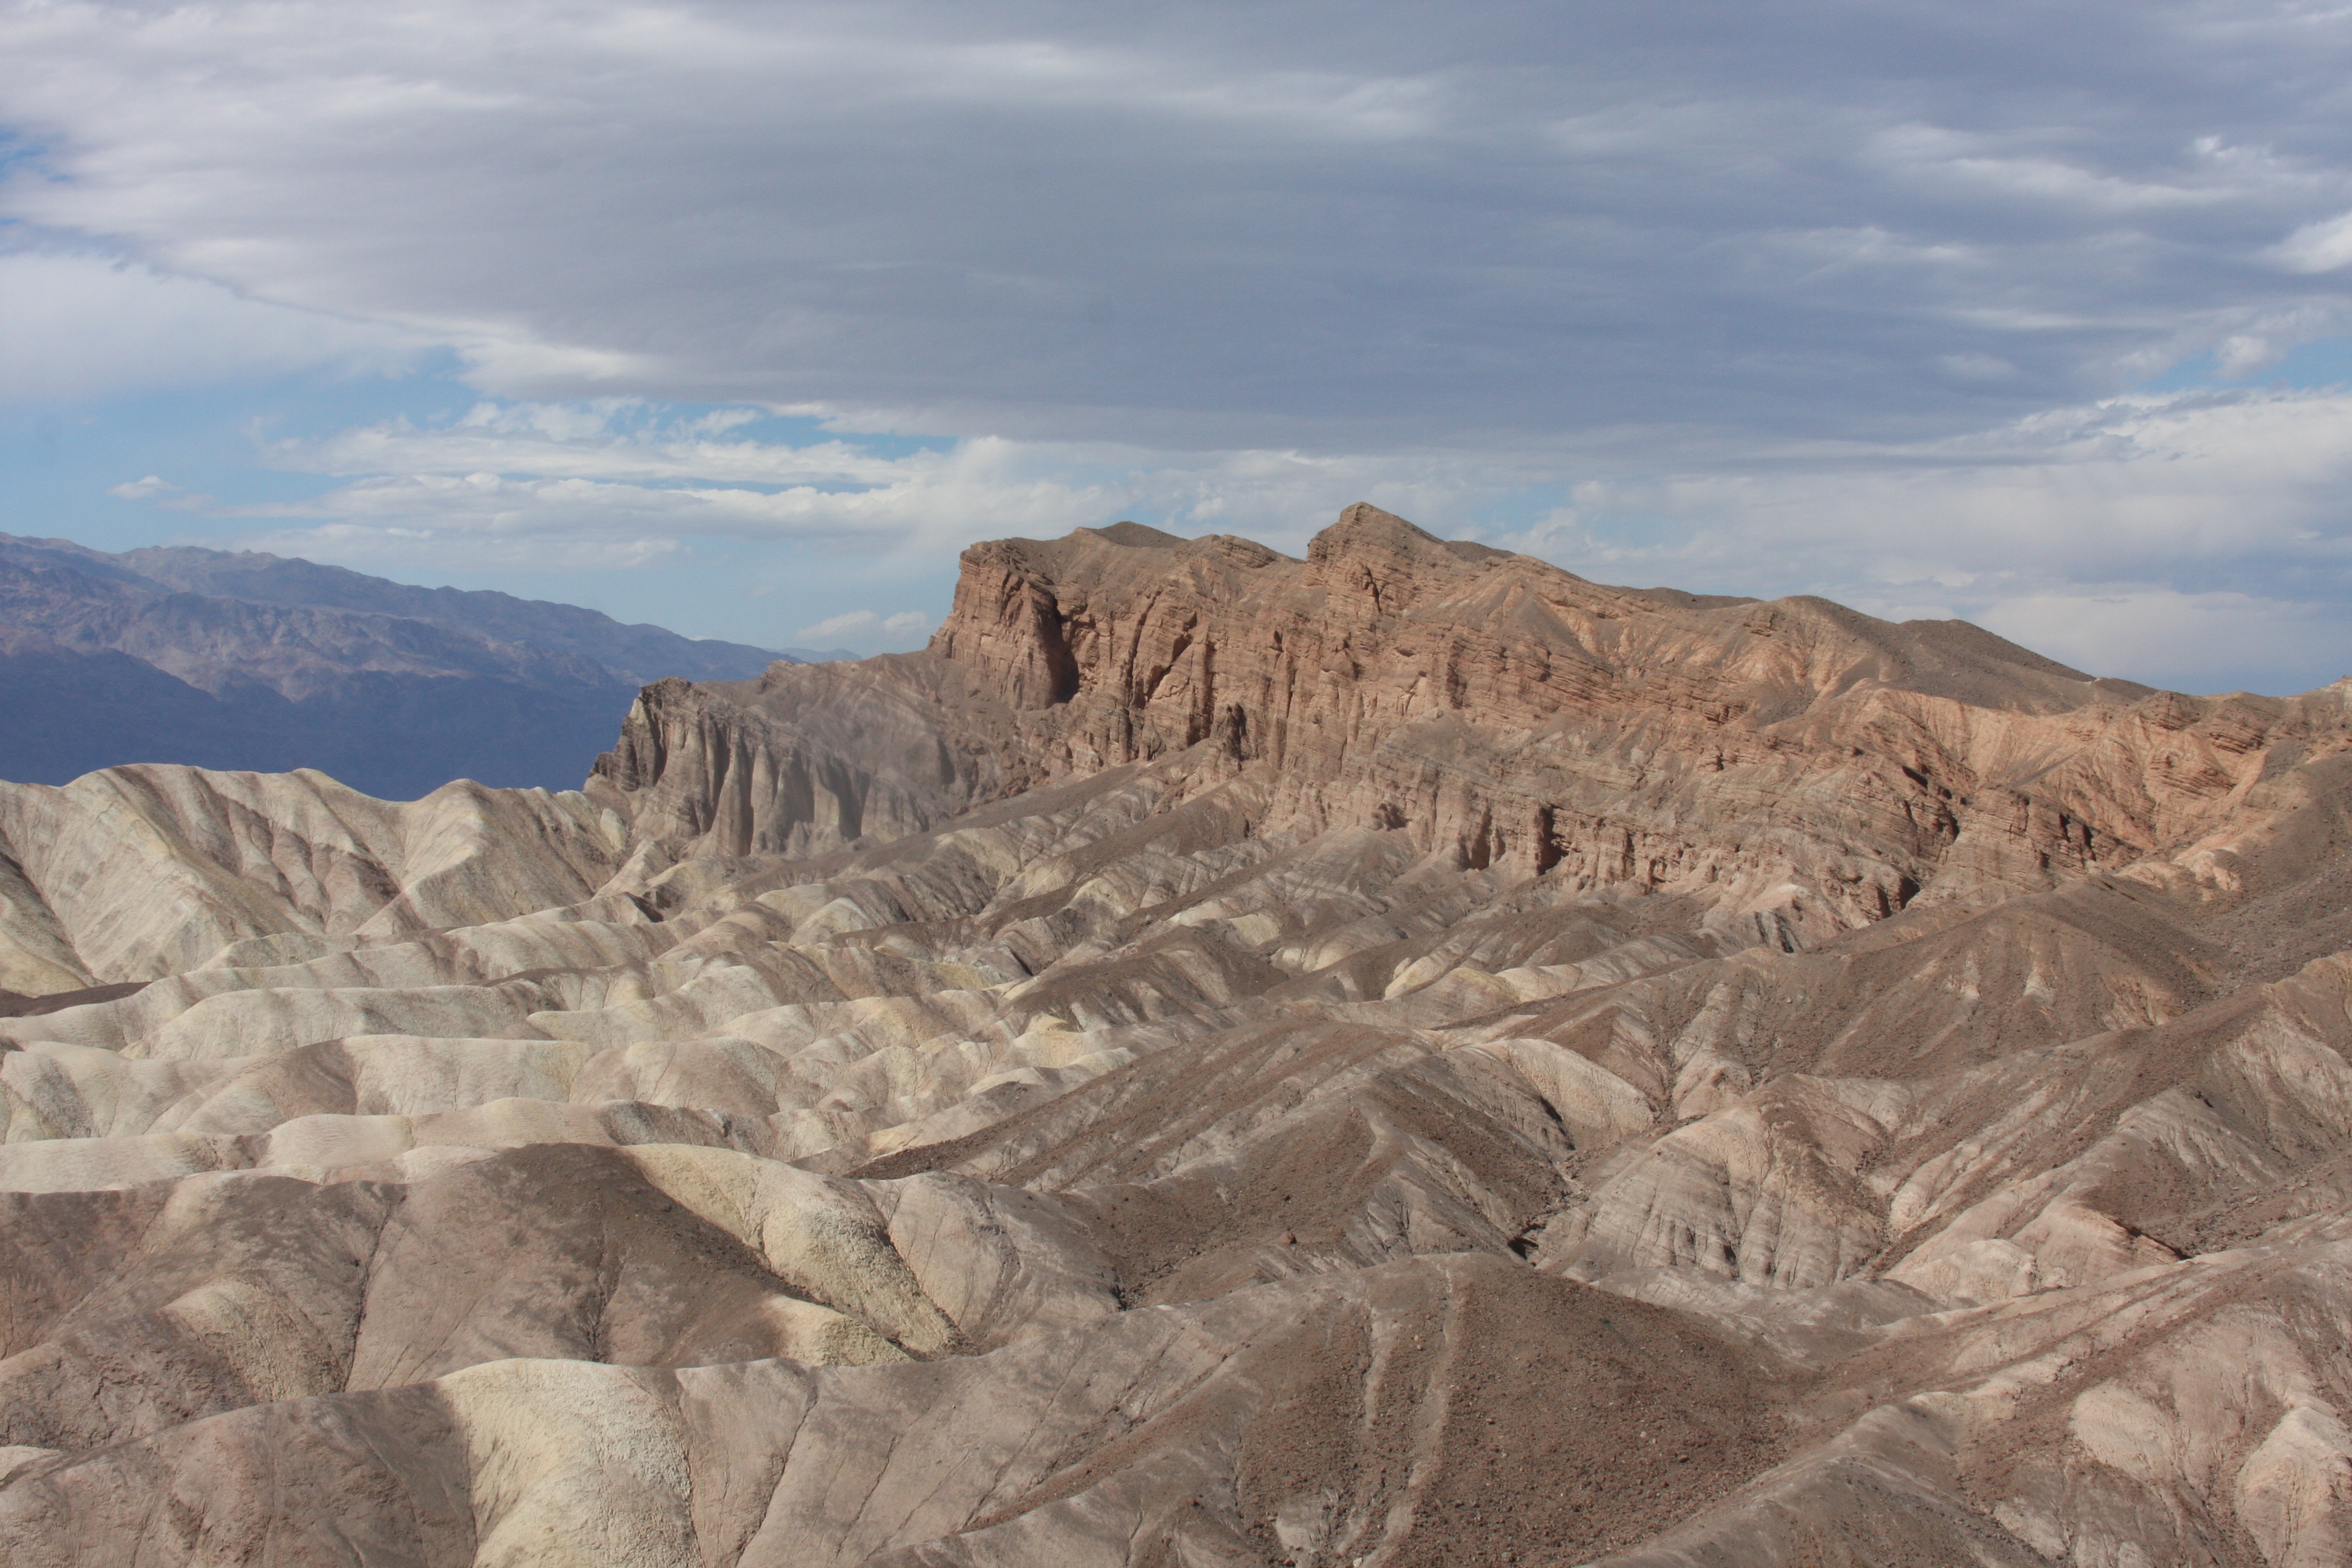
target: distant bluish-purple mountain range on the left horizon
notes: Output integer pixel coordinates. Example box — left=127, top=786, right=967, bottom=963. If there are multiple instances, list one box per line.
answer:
left=0, top=534, right=786, bottom=799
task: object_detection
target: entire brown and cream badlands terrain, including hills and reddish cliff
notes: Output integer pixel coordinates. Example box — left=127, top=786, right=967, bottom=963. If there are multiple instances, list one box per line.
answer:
left=0, top=506, right=2352, bottom=1568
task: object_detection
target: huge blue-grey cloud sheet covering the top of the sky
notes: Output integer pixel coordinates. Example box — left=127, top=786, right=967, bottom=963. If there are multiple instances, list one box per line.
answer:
left=0, top=0, right=2352, bottom=454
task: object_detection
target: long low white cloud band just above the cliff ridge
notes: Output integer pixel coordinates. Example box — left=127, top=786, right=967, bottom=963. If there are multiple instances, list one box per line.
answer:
left=87, top=371, right=2352, bottom=689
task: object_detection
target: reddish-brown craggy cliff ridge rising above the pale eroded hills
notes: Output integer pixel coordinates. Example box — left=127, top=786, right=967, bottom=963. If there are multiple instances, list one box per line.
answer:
left=598, top=506, right=2347, bottom=936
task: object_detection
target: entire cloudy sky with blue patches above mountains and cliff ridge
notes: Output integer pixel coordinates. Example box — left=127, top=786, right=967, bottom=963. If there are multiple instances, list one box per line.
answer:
left=0, top=0, right=2352, bottom=693
